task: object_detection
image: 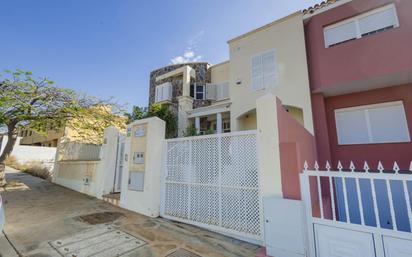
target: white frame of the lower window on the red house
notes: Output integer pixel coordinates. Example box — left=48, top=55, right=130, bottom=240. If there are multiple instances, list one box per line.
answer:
left=335, top=101, right=411, bottom=145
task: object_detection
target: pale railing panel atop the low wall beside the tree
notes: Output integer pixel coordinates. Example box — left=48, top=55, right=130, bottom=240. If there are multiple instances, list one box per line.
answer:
left=58, top=142, right=101, bottom=161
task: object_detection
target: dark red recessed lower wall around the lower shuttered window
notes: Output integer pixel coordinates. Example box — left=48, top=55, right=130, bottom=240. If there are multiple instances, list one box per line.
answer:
left=312, top=84, right=412, bottom=170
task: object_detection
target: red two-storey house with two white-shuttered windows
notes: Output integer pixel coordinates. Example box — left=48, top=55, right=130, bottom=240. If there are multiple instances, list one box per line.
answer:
left=303, top=0, right=412, bottom=170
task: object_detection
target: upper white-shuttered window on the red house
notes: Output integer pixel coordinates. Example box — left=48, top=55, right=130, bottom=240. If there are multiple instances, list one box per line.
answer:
left=324, top=4, right=399, bottom=47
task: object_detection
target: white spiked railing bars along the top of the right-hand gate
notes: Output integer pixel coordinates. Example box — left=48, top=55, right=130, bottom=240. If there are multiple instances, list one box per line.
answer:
left=301, top=162, right=412, bottom=238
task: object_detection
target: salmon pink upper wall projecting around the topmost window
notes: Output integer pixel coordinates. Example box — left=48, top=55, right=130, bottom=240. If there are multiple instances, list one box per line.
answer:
left=305, top=0, right=412, bottom=91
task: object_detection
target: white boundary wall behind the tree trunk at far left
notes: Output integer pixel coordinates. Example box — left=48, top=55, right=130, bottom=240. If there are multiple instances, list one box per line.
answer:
left=0, top=136, right=57, bottom=169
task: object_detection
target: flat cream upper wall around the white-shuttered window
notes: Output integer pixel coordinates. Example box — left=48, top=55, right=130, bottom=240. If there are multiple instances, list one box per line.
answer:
left=228, top=13, right=313, bottom=133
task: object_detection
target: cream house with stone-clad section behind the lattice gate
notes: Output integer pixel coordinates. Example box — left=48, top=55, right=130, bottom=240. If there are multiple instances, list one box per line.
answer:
left=149, top=12, right=313, bottom=137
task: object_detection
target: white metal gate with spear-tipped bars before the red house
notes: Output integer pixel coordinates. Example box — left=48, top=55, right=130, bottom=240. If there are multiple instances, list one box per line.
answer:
left=301, top=162, right=412, bottom=257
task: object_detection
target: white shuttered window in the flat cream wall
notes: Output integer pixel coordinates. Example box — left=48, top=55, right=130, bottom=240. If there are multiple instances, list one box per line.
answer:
left=250, top=50, right=277, bottom=91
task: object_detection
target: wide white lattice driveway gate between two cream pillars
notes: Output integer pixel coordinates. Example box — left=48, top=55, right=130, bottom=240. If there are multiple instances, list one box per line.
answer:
left=161, top=131, right=263, bottom=243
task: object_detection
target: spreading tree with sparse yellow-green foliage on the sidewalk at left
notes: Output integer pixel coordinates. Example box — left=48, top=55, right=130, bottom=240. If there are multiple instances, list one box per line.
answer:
left=0, top=69, right=124, bottom=186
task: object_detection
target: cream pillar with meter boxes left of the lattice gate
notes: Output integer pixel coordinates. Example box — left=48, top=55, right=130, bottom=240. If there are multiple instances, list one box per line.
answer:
left=120, top=117, right=166, bottom=217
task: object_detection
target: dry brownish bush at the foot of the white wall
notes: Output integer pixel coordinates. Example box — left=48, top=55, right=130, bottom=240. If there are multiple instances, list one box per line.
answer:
left=4, top=155, right=52, bottom=181
